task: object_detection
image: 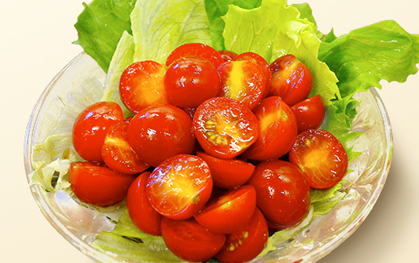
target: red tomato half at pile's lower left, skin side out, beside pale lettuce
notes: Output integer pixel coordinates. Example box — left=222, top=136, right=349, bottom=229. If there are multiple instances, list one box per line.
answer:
left=68, top=162, right=135, bottom=206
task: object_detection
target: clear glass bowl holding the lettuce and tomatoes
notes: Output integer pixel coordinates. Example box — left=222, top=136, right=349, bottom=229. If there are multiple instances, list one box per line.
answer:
left=24, top=53, right=393, bottom=263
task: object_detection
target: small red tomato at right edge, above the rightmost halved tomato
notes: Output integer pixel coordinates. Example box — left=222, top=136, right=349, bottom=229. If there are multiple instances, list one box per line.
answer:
left=291, top=95, right=326, bottom=133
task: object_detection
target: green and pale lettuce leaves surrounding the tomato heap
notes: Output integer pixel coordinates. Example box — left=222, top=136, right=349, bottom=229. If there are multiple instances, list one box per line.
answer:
left=27, top=0, right=419, bottom=261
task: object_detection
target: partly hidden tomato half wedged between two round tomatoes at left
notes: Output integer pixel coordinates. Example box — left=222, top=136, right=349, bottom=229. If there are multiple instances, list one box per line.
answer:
left=102, top=122, right=149, bottom=174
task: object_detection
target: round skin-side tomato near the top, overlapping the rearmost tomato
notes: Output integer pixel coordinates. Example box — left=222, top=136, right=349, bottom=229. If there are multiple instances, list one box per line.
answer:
left=164, top=57, right=220, bottom=108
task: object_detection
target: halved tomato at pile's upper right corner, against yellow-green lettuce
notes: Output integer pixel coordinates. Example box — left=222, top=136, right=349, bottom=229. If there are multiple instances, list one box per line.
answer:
left=269, top=54, right=313, bottom=107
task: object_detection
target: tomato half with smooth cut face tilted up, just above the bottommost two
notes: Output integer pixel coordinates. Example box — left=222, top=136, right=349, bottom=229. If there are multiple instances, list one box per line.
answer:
left=195, top=185, right=256, bottom=234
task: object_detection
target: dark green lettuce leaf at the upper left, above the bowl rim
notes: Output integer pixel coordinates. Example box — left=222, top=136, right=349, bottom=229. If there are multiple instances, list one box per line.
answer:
left=74, top=0, right=136, bottom=72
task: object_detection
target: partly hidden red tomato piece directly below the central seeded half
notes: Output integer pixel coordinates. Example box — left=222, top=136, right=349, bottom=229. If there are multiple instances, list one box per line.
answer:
left=196, top=152, right=255, bottom=189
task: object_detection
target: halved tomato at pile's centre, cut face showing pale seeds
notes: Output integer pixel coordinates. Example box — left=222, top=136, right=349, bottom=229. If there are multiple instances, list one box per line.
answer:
left=193, top=97, right=259, bottom=159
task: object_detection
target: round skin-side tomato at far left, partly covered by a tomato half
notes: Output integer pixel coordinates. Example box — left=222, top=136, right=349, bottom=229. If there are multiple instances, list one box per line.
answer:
left=73, top=101, right=124, bottom=162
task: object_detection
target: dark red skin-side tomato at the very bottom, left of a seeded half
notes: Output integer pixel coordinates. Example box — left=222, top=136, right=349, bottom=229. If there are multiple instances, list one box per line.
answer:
left=161, top=217, right=226, bottom=262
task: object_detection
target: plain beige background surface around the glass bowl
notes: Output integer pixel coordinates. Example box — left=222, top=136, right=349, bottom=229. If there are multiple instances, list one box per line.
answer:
left=0, top=0, right=419, bottom=263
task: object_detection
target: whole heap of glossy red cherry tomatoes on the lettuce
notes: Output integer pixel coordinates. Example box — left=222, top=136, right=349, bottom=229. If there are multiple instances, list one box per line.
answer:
left=69, top=43, right=348, bottom=262
